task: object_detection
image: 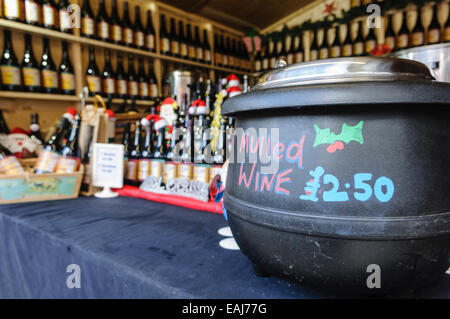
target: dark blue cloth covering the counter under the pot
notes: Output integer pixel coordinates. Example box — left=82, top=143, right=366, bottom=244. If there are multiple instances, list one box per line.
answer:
left=0, top=197, right=450, bottom=298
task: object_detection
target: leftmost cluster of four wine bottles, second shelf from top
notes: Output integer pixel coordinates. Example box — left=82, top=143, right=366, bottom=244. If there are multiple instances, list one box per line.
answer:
left=0, top=29, right=75, bottom=94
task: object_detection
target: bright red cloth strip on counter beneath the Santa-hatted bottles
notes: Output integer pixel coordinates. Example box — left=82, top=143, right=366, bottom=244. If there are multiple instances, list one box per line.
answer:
left=115, top=185, right=223, bottom=214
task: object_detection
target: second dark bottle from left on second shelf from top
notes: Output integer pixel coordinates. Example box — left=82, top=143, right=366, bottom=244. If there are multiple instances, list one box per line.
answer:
left=22, top=33, right=41, bottom=92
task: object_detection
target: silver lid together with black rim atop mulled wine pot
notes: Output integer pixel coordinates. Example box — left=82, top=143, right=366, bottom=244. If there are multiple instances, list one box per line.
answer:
left=222, top=57, right=450, bottom=115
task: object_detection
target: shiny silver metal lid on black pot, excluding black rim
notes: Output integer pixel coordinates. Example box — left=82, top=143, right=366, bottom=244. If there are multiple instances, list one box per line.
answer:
left=252, top=57, right=434, bottom=90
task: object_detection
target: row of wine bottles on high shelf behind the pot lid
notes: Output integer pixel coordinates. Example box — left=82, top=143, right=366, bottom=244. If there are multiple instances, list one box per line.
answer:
left=255, top=5, right=450, bottom=72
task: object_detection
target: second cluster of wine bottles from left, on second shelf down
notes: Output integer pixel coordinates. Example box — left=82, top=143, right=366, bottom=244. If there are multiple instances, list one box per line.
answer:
left=86, top=47, right=158, bottom=100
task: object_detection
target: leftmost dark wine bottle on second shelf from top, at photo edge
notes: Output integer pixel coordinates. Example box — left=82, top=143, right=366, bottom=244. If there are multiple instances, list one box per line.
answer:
left=0, top=29, right=22, bottom=91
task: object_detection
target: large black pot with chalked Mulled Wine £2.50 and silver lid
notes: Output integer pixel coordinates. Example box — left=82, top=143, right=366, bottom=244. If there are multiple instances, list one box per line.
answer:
left=222, top=58, right=450, bottom=294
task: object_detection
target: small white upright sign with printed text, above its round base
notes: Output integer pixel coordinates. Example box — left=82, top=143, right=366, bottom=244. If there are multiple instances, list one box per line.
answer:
left=92, top=143, right=123, bottom=188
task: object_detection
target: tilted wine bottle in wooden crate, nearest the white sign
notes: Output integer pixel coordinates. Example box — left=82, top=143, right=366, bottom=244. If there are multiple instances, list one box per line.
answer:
left=55, top=115, right=81, bottom=173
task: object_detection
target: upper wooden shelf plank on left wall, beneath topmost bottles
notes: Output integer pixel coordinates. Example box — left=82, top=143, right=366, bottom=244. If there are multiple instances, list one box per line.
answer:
left=0, top=19, right=251, bottom=76
